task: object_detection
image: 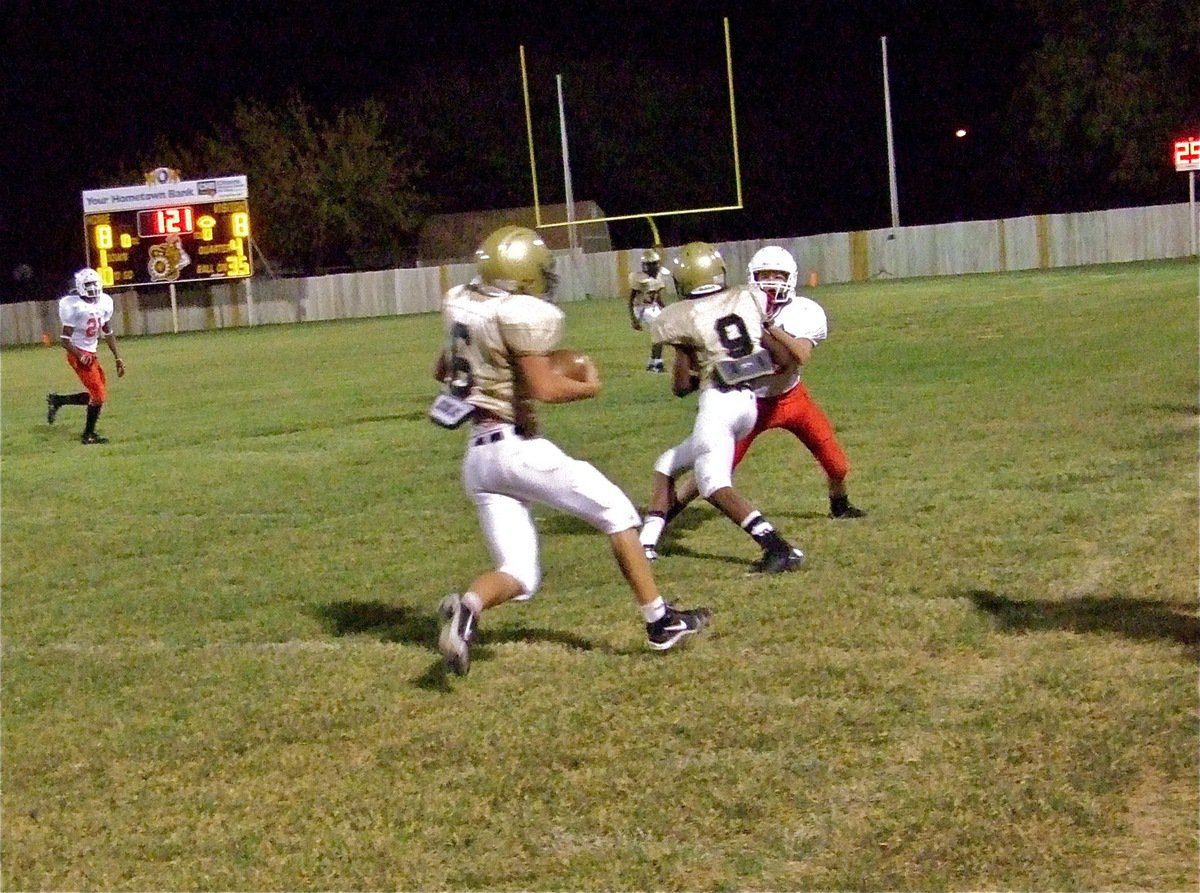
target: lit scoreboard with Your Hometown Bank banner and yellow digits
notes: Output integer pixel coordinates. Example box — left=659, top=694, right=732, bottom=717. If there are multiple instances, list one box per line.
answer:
left=83, top=175, right=253, bottom=288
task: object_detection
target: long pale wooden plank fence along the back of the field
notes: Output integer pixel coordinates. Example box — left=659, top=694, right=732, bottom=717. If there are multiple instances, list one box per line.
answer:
left=0, top=204, right=1193, bottom=346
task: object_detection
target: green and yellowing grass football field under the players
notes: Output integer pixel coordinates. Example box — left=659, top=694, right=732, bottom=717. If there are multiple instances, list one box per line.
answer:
left=0, top=263, right=1200, bottom=891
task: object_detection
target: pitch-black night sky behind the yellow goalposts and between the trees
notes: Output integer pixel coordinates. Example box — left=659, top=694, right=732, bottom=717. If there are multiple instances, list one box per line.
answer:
left=0, top=0, right=1072, bottom=296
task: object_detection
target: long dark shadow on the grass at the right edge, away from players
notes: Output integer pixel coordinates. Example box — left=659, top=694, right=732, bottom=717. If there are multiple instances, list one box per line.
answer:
left=964, top=589, right=1200, bottom=660
